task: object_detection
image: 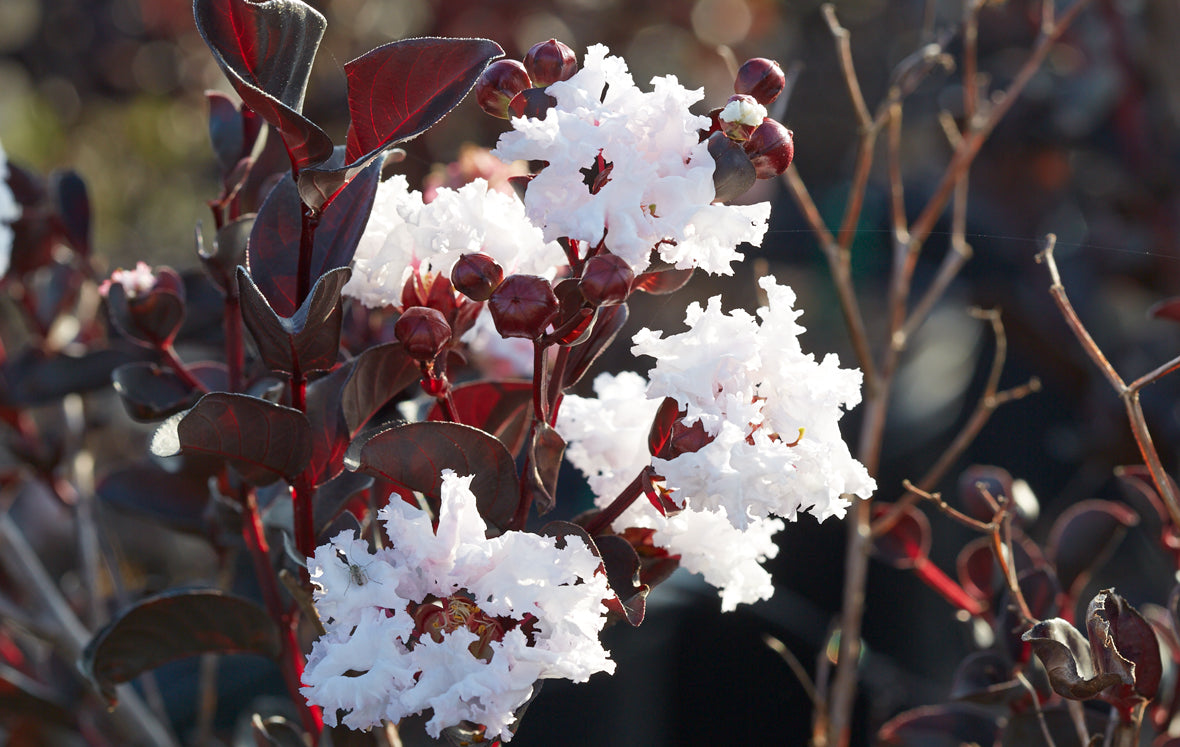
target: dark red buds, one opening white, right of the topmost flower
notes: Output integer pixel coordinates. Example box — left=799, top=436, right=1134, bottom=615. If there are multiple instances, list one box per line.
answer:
left=701, top=57, right=795, bottom=179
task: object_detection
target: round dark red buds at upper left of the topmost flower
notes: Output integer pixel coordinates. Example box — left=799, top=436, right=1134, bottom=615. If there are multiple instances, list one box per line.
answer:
left=476, top=39, right=578, bottom=119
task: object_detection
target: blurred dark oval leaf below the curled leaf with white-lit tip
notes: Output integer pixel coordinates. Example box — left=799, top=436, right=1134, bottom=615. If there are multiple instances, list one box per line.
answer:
left=96, top=464, right=209, bottom=535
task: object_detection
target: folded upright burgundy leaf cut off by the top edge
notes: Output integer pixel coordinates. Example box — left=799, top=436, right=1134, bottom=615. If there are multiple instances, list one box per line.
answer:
left=194, top=0, right=332, bottom=169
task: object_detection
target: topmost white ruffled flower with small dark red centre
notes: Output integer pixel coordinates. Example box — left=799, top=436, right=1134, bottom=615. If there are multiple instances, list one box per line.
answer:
left=492, top=45, right=771, bottom=275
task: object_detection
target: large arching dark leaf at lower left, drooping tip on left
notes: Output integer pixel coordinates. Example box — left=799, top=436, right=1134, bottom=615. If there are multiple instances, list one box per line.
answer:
left=79, top=590, right=282, bottom=703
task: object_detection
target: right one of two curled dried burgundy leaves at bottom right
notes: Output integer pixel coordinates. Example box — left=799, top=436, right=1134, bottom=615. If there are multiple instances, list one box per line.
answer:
left=1086, top=589, right=1163, bottom=710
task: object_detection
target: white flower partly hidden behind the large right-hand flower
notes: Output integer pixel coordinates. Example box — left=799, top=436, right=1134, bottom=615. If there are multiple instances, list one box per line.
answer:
left=557, top=372, right=784, bottom=611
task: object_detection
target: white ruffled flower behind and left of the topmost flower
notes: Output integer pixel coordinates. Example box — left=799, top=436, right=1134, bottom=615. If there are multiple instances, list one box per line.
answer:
left=343, top=175, right=566, bottom=308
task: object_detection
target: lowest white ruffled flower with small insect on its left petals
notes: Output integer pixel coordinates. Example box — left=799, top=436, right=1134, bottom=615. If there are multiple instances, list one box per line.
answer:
left=302, top=470, right=615, bottom=741
